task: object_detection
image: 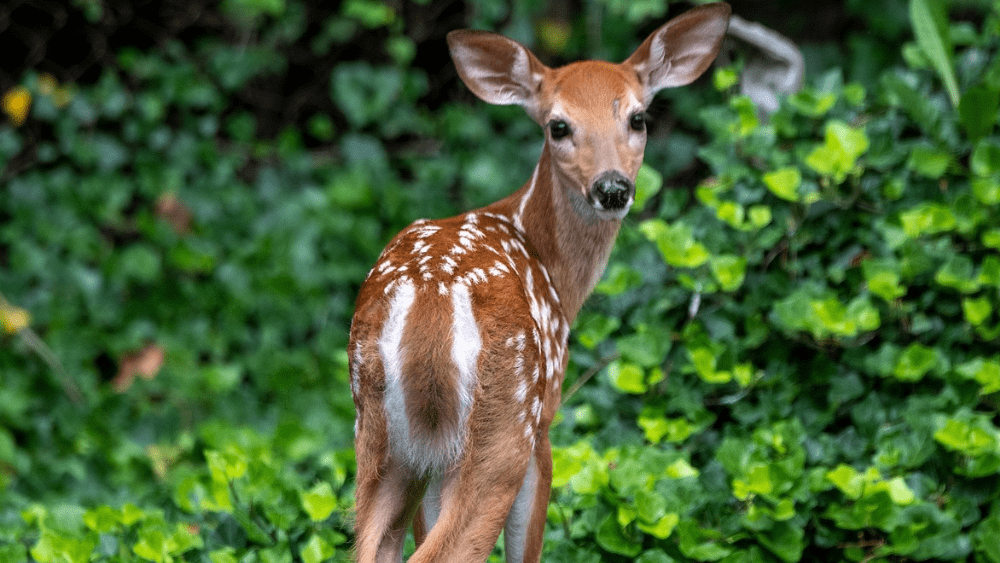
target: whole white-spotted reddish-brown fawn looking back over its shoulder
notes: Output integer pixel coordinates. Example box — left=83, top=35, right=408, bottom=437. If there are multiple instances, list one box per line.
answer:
left=349, top=3, right=729, bottom=563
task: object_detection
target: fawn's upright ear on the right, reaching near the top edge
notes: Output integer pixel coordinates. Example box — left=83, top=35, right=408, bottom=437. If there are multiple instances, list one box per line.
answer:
left=624, top=2, right=730, bottom=101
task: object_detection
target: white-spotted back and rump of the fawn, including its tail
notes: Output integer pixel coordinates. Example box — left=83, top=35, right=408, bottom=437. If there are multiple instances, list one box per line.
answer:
left=350, top=211, right=569, bottom=472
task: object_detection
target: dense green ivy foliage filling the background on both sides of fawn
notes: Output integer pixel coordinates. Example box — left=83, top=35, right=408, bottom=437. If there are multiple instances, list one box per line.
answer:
left=0, top=0, right=1000, bottom=563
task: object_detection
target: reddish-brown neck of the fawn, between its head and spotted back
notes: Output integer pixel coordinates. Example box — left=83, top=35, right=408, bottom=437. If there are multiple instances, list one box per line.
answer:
left=497, top=143, right=621, bottom=322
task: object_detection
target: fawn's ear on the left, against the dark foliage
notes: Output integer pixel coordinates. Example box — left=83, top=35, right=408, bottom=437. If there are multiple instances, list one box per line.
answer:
left=448, top=30, right=549, bottom=116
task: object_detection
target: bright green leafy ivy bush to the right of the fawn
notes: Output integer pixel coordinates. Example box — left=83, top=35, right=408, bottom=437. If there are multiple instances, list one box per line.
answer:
left=550, top=2, right=1000, bottom=562
